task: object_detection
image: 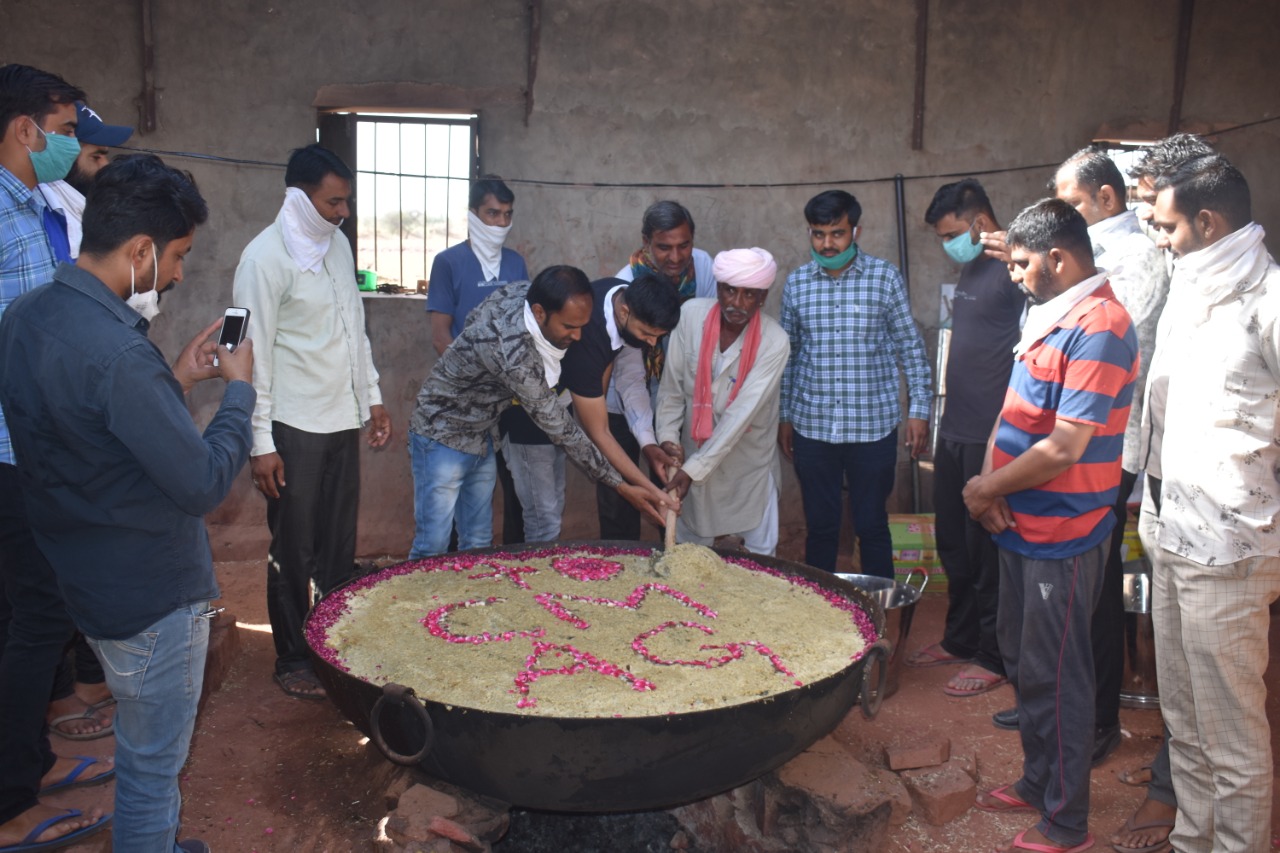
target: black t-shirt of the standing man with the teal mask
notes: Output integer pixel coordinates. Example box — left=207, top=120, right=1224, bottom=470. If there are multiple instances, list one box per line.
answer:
left=938, top=255, right=1027, bottom=444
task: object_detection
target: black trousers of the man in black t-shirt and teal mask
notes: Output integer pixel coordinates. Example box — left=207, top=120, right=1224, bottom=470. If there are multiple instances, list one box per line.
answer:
left=933, top=438, right=1005, bottom=675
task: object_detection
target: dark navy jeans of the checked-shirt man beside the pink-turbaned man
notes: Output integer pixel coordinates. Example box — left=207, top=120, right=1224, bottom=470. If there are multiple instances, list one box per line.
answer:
left=792, top=429, right=897, bottom=578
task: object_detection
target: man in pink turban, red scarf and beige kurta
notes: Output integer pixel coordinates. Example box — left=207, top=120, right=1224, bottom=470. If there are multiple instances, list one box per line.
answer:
left=657, top=248, right=791, bottom=555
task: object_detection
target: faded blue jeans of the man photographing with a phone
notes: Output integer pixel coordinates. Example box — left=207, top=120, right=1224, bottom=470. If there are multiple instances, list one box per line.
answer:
left=88, top=602, right=209, bottom=853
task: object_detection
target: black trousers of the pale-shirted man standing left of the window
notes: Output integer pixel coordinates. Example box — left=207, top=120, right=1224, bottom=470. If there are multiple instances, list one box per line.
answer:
left=266, top=421, right=360, bottom=672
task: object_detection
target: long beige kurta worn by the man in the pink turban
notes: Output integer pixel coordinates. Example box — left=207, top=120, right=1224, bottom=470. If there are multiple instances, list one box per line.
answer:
left=655, top=298, right=791, bottom=537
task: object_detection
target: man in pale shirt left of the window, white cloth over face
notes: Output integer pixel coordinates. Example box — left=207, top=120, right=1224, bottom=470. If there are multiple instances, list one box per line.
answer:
left=234, top=145, right=392, bottom=699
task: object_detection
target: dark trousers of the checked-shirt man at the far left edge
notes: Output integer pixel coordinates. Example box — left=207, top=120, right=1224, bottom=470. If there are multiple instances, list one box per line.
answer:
left=0, top=464, right=76, bottom=824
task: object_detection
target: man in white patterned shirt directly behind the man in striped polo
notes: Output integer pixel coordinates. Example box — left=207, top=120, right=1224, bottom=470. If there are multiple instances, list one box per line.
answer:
left=1053, top=147, right=1169, bottom=765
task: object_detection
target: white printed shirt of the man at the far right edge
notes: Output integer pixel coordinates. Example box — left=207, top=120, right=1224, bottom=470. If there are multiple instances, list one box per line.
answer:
left=1148, top=224, right=1280, bottom=566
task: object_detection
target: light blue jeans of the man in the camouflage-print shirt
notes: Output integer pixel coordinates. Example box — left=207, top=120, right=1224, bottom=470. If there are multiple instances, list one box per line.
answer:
left=408, top=433, right=498, bottom=560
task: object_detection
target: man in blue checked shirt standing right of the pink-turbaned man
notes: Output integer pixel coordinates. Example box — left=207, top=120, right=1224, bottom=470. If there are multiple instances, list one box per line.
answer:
left=778, top=190, right=932, bottom=578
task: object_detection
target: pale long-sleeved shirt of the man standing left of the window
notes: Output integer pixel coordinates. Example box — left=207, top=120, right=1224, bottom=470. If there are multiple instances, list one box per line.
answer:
left=233, top=212, right=383, bottom=456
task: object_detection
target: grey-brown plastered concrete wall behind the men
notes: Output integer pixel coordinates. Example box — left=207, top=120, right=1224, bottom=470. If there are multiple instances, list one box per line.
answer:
left=0, top=0, right=1280, bottom=557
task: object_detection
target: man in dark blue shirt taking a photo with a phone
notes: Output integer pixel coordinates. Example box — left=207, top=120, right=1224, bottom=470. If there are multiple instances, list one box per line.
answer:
left=0, top=156, right=255, bottom=853
